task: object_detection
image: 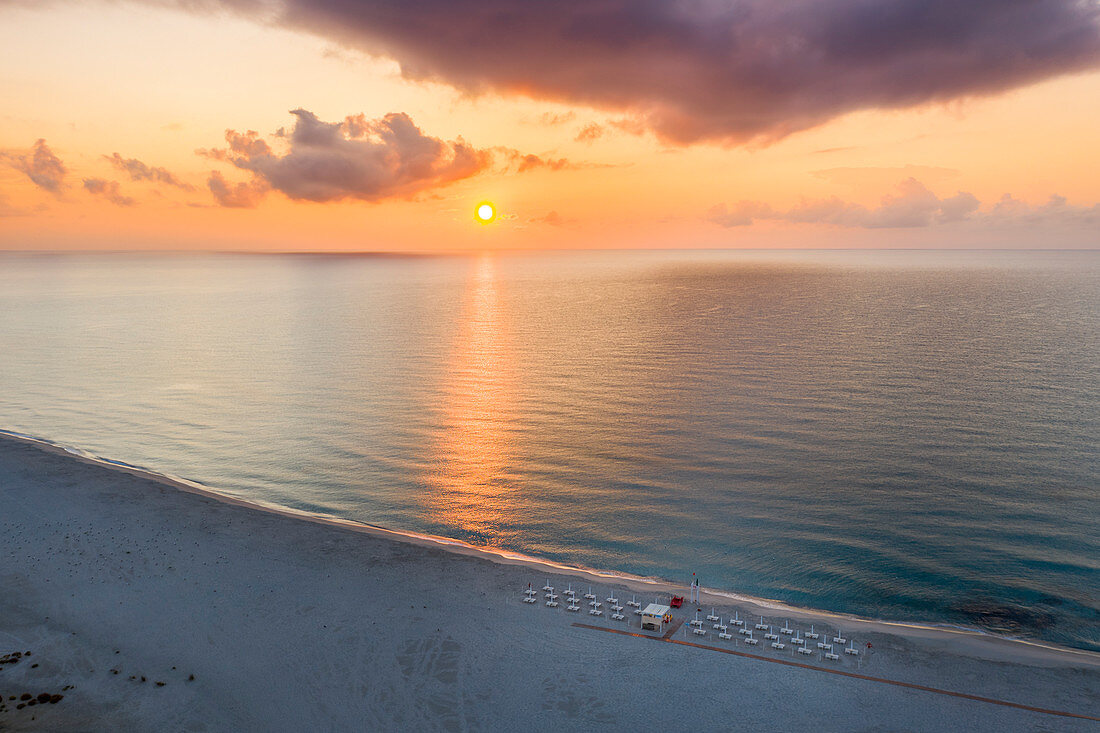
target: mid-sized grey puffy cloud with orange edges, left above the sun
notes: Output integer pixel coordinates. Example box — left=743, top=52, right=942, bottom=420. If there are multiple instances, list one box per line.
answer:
left=198, top=109, right=491, bottom=206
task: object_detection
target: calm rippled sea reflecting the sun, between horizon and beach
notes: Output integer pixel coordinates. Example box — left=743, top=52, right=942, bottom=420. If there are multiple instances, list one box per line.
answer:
left=0, top=252, right=1100, bottom=649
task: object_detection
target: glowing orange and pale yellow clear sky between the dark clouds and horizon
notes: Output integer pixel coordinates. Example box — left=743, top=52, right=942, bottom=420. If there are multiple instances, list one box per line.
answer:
left=0, top=2, right=1100, bottom=251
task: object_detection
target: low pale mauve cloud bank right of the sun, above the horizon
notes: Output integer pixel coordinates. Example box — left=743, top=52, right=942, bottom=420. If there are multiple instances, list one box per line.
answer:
left=706, top=178, right=980, bottom=229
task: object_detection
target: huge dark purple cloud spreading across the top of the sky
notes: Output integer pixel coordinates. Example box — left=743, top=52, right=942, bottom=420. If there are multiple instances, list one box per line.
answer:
left=176, top=0, right=1100, bottom=143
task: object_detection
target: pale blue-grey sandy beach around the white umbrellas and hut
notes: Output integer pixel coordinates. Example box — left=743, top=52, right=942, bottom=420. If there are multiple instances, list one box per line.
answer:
left=0, top=437, right=1100, bottom=732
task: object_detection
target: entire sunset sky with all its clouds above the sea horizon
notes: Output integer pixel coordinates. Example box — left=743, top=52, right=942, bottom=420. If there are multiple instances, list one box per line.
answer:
left=0, top=0, right=1100, bottom=252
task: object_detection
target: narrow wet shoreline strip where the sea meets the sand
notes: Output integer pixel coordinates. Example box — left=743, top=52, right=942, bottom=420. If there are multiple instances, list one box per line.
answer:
left=0, top=428, right=1100, bottom=668
